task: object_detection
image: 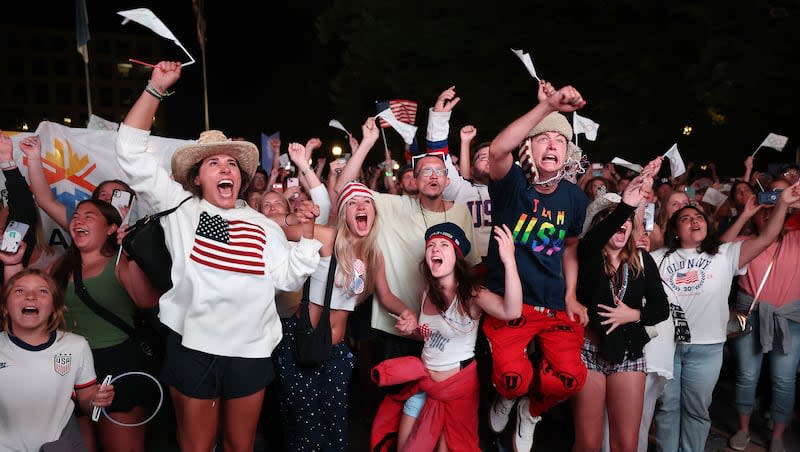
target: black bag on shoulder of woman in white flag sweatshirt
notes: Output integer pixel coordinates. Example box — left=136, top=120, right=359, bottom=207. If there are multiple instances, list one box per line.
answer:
left=122, top=196, right=192, bottom=293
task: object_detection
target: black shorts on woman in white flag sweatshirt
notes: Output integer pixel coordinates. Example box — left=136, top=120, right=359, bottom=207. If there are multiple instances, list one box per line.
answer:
left=161, top=329, right=275, bottom=400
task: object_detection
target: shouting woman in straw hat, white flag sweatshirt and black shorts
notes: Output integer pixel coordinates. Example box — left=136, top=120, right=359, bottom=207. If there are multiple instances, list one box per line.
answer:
left=117, top=61, right=320, bottom=452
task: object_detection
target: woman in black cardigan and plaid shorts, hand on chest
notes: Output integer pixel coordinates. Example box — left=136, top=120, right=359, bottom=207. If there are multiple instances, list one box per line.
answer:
left=572, top=158, right=669, bottom=451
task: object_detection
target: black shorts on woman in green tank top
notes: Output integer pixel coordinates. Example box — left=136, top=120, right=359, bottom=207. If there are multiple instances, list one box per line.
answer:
left=92, top=339, right=152, bottom=413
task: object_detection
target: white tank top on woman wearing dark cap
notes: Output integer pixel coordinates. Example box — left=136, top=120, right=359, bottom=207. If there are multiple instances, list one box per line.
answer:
left=419, top=294, right=478, bottom=371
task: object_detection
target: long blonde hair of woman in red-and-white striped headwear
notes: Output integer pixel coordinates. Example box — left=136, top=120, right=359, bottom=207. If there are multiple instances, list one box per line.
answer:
left=334, top=199, right=383, bottom=302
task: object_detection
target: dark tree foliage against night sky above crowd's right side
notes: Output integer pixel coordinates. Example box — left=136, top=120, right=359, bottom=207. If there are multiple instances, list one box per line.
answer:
left=317, top=0, right=800, bottom=175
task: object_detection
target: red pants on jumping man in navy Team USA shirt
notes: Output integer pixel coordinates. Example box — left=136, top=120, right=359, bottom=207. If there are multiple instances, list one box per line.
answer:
left=483, top=305, right=586, bottom=416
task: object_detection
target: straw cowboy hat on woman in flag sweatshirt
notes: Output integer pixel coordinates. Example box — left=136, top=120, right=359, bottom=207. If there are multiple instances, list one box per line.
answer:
left=172, top=130, right=258, bottom=191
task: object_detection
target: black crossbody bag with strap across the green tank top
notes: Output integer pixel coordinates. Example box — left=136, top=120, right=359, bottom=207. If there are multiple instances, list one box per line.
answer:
left=72, top=262, right=166, bottom=375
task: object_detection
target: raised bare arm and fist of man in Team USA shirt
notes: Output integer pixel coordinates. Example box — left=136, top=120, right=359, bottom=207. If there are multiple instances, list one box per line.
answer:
left=489, top=81, right=586, bottom=180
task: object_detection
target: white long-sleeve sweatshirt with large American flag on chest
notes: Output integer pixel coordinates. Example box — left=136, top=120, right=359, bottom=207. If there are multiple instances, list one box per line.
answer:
left=117, top=124, right=321, bottom=358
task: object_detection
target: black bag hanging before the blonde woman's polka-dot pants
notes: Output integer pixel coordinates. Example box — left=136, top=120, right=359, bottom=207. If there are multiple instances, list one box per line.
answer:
left=294, top=255, right=336, bottom=367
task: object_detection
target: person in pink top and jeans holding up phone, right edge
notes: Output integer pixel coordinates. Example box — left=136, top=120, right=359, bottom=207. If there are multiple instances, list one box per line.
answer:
left=722, top=179, right=800, bottom=450
